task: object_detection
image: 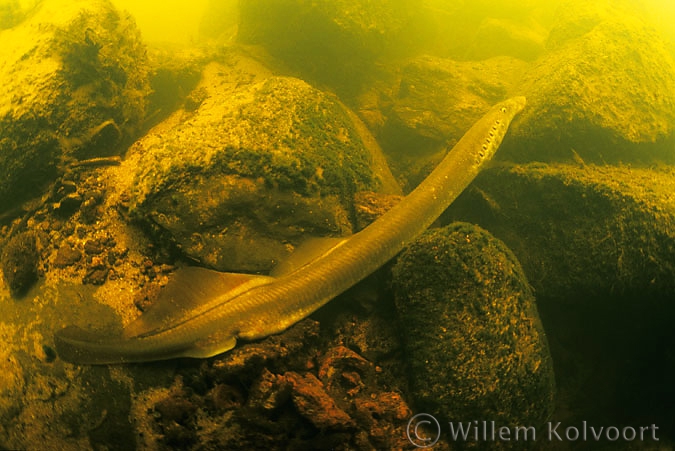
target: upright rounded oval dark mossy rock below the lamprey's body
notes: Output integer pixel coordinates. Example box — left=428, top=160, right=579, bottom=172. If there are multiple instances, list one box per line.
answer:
left=393, top=223, right=554, bottom=425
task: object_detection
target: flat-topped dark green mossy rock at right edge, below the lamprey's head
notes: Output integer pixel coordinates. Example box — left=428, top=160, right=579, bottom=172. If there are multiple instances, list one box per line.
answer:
left=449, top=164, right=675, bottom=302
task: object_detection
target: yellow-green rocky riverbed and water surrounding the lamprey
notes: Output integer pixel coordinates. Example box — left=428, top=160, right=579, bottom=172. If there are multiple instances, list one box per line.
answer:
left=0, top=0, right=675, bottom=450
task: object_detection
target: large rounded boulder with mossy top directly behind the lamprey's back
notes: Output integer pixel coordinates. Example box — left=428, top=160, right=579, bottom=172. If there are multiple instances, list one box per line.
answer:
left=126, top=63, right=399, bottom=271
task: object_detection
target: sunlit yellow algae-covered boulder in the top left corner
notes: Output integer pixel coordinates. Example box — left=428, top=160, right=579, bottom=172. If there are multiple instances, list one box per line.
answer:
left=0, top=0, right=148, bottom=211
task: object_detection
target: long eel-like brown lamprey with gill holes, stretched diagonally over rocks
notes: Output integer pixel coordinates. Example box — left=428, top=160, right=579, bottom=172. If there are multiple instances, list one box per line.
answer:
left=55, top=97, right=525, bottom=364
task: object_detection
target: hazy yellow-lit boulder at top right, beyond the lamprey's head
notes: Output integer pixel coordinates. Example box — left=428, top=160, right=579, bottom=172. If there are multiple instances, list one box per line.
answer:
left=510, top=1, right=675, bottom=163
